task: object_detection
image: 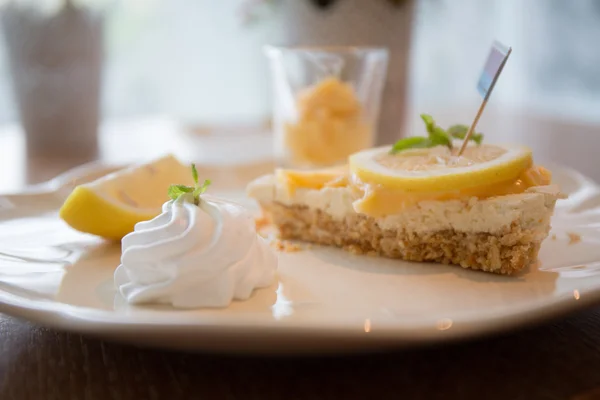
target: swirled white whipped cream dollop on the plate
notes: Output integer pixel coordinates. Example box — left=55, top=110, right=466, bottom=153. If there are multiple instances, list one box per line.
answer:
left=115, top=195, right=277, bottom=308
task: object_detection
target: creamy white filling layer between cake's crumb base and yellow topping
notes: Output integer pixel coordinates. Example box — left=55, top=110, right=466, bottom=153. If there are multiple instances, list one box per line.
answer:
left=247, top=175, right=561, bottom=240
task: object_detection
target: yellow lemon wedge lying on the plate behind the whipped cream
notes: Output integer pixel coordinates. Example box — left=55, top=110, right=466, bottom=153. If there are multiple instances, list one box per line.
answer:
left=59, top=156, right=193, bottom=240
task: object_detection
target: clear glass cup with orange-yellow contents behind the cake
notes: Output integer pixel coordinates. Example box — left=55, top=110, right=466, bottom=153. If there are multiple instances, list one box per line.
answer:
left=265, top=46, right=388, bottom=169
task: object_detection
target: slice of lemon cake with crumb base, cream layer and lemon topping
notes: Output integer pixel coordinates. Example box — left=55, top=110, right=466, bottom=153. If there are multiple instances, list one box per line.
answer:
left=248, top=115, right=561, bottom=274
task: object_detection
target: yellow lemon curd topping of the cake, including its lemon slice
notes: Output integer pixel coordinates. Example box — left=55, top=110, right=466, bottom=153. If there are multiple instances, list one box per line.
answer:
left=277, top=145, right=551, bottom=217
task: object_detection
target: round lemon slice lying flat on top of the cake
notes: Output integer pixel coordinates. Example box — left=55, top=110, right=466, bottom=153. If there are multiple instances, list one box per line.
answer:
left=349, top=145, right=533, bottom=193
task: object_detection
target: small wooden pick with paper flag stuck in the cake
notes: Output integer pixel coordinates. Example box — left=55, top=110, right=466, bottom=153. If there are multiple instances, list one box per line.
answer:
left=458, top=41, right=512, bottom=156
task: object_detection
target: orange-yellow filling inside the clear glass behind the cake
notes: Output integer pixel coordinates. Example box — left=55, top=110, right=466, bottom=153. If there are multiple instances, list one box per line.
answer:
left=284, top=77, right=372, bottom=166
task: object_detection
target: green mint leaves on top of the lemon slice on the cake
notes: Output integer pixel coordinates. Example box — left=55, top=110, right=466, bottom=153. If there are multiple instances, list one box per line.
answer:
left=390, top=114, right=483, bottom=154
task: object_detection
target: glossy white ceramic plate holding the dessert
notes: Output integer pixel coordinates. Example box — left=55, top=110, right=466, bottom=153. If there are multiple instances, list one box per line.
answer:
left=0, top=161, right=600, bottom=353
